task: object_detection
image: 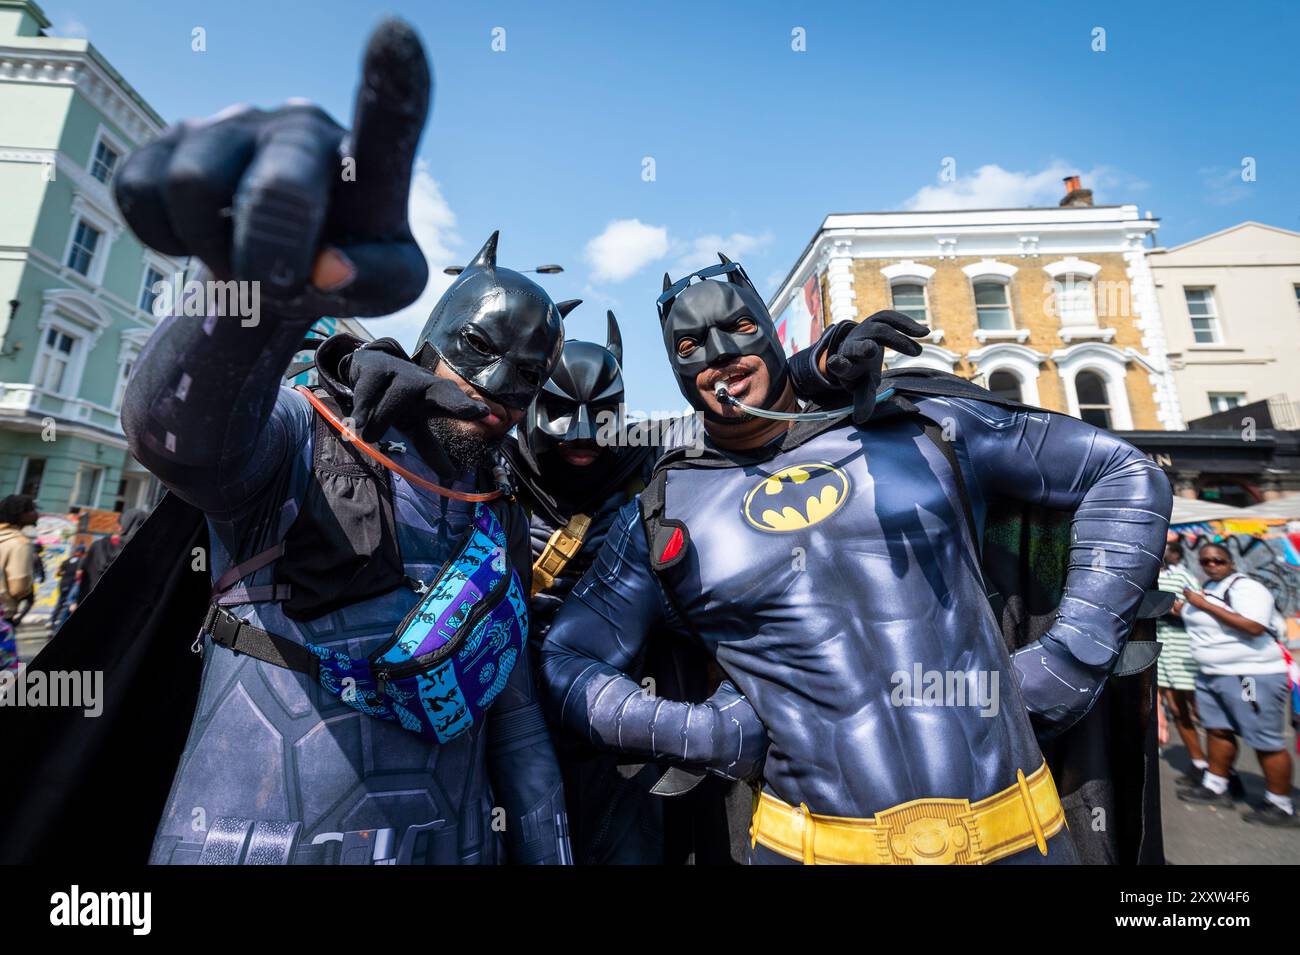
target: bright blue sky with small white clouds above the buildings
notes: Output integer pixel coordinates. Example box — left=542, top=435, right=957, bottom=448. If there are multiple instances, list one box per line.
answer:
left=42, top=0, right=1300, bottom=411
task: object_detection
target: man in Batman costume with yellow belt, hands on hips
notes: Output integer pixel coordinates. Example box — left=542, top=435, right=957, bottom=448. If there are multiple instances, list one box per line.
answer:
left=541, top=255, right=1171, bottom=864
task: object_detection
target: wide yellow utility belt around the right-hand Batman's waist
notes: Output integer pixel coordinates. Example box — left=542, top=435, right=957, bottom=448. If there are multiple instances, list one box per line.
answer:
left=749, top=763, right=1065, bottom=865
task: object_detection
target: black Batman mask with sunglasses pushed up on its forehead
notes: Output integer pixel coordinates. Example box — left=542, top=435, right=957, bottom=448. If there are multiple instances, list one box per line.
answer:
left=659, top=252, right=788, bottom=422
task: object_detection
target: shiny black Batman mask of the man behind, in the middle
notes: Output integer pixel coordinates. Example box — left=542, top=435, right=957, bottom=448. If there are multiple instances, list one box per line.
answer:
left=524, top=301, right=623, bottom=455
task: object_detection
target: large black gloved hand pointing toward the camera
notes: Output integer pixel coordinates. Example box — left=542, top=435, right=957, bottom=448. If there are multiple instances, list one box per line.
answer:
left=113, top=19, right=433, bottom=317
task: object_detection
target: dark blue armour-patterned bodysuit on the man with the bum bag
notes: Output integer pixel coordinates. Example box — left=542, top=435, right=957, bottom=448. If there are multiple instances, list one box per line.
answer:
left=122, top=281, right=568, bottom=864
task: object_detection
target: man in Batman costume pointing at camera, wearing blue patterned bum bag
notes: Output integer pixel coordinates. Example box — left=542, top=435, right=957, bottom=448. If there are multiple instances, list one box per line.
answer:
left=0, top=21, right=568, bottom=864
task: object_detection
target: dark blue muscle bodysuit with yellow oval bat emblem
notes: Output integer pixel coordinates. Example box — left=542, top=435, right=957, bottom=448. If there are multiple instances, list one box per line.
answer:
left=542, top=398, right=1171, bottom=861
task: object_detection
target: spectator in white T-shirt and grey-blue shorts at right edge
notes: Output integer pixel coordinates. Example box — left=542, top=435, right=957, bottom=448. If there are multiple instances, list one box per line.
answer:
left=1178, top=544, right=1300, bottom=826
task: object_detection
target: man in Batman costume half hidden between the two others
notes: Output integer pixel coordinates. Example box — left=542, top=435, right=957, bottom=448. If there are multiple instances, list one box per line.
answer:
left=503, top=300, right=873, bottom=864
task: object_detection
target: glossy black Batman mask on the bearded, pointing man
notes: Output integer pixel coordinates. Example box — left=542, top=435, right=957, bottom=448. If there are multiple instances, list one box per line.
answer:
left=415, top=233, right=564, bottom=408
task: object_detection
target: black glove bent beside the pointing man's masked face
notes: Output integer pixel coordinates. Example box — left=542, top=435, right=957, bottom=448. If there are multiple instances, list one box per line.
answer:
left=342, top=339, right=488, bottom=442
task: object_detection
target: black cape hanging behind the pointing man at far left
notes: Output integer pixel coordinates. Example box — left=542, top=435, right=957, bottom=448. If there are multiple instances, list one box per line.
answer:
left=0, top=494, right=212, bottom=864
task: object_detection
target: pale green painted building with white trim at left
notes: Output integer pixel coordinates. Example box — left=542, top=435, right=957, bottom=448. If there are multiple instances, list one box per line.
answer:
left=0, top=0, right=371, bottom=522
